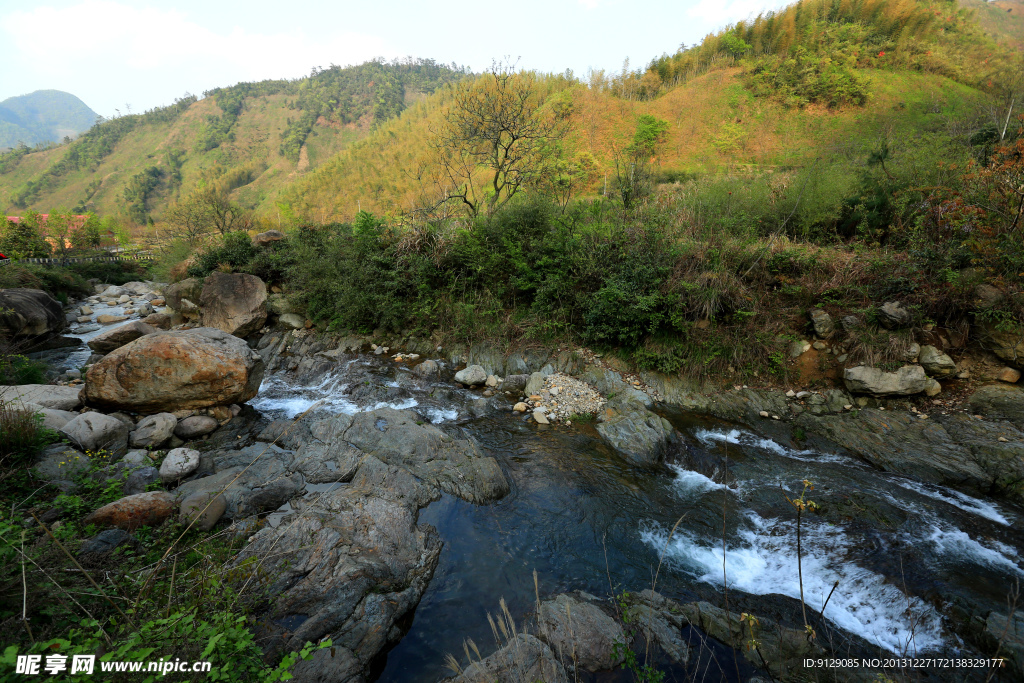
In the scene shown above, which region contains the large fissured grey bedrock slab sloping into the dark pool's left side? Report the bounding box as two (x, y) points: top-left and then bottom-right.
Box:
(234, 457), (441, 682)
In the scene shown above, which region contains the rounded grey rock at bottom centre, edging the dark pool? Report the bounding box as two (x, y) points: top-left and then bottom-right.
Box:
(539, 594), (628, 672)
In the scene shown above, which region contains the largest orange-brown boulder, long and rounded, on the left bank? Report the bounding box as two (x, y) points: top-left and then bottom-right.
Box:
(85, 328), (263, 414)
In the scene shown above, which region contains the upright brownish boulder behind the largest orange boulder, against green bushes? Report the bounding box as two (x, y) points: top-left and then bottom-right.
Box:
(199, 272), (266, 337)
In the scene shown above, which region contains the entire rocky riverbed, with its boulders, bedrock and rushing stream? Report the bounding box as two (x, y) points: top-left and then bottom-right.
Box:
(6, 278), (1024, 681)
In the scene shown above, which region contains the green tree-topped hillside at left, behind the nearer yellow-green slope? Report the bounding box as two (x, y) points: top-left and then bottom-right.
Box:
(0, 59), (465, 223)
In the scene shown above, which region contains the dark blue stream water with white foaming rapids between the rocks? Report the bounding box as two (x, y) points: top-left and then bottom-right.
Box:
(37, 306), (1024, 683)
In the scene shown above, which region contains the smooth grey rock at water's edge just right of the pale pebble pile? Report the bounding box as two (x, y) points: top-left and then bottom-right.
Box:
(597, 400), (674, 467)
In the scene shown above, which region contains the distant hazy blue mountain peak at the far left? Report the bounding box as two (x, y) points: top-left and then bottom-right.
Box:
(0, 90), (99, 150)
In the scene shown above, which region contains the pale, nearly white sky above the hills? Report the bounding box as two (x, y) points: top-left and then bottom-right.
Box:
(0, 0), (788, 117)
